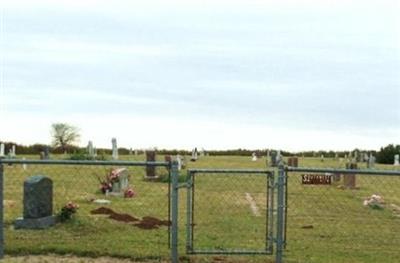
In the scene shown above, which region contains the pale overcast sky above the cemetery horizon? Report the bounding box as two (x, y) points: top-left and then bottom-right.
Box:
(0, 0), (400, 151)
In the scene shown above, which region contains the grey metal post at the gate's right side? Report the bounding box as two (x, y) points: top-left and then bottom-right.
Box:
(275, 164), (286, 263)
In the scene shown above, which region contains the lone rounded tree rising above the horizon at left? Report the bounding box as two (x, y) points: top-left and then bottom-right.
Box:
(51, 123), (80, 152)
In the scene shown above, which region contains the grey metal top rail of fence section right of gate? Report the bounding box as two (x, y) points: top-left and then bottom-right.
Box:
(285, 166), (400, 176)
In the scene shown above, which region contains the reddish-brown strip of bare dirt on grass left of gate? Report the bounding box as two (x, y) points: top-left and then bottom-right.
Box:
(90, 207), (171, 229)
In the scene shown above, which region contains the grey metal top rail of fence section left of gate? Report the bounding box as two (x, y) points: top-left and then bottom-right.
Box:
(0, 158), (171, 167)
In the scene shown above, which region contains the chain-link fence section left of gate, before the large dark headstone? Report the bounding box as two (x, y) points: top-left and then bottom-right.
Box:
(2, 160), (170, 260)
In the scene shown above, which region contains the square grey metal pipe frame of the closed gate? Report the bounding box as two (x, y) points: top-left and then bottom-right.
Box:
(186, 169), (275, 255)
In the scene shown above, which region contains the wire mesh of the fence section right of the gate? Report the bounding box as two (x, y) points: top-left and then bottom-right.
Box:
(285, 169), (400, 263)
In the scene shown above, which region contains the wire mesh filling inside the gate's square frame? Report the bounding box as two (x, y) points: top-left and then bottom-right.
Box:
(188, 170), (272, 254)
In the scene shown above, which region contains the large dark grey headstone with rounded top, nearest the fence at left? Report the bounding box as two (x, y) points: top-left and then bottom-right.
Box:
(14, 175), (55, 229)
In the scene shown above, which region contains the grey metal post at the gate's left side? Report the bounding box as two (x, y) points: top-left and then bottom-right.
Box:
(171, 161), (179, 263)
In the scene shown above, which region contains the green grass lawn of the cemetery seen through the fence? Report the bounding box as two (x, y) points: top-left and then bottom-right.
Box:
(4, 155), (400, 263)
